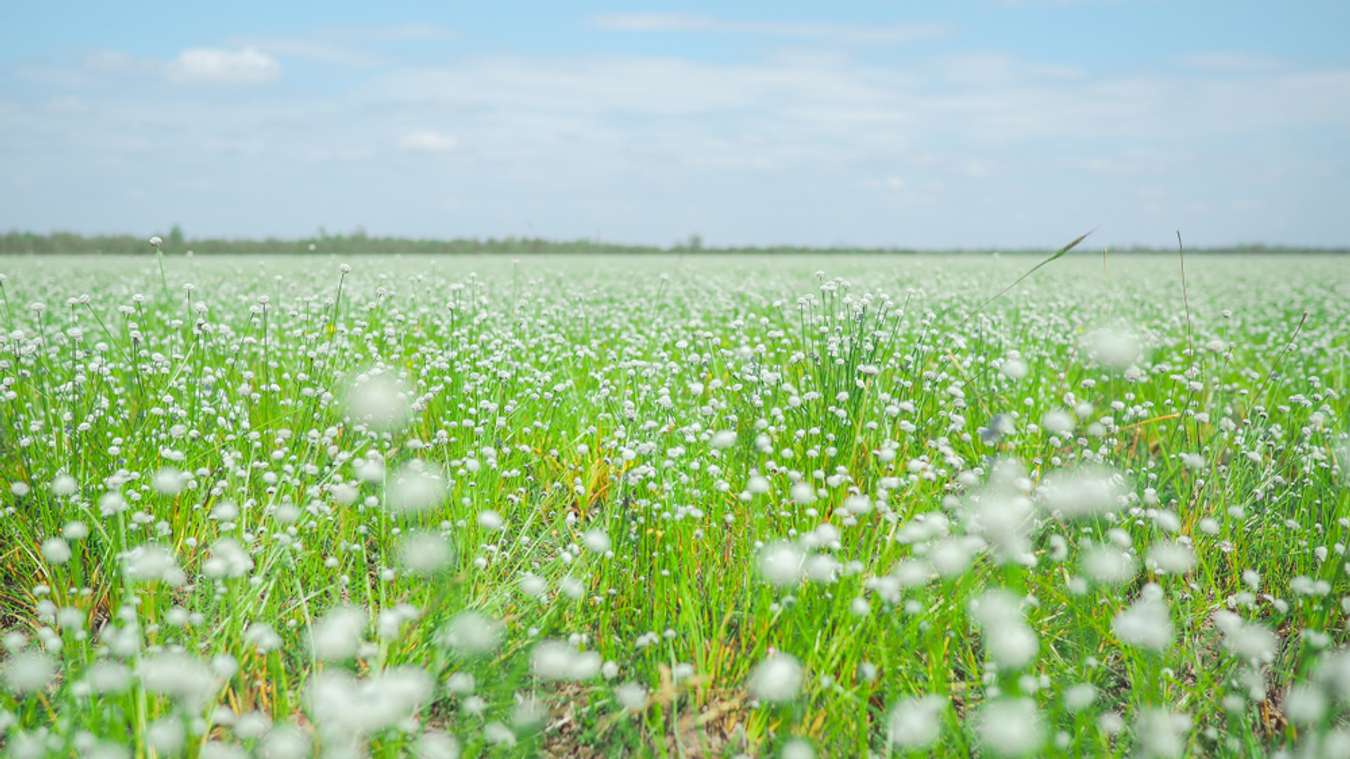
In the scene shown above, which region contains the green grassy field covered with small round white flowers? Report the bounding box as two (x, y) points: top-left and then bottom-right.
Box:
(0, 251), (1350, 759)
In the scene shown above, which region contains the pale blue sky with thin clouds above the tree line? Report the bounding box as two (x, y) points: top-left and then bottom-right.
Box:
(0, 0), (1350, 248)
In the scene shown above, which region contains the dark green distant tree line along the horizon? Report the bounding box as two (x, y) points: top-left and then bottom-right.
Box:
(0, 226), (1350, 255)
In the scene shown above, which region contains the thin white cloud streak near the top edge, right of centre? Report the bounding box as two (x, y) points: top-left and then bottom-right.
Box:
(591, 14), (946, 45)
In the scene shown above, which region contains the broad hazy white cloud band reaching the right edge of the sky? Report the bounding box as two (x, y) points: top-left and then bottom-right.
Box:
(373, 57), (1350, 147)
